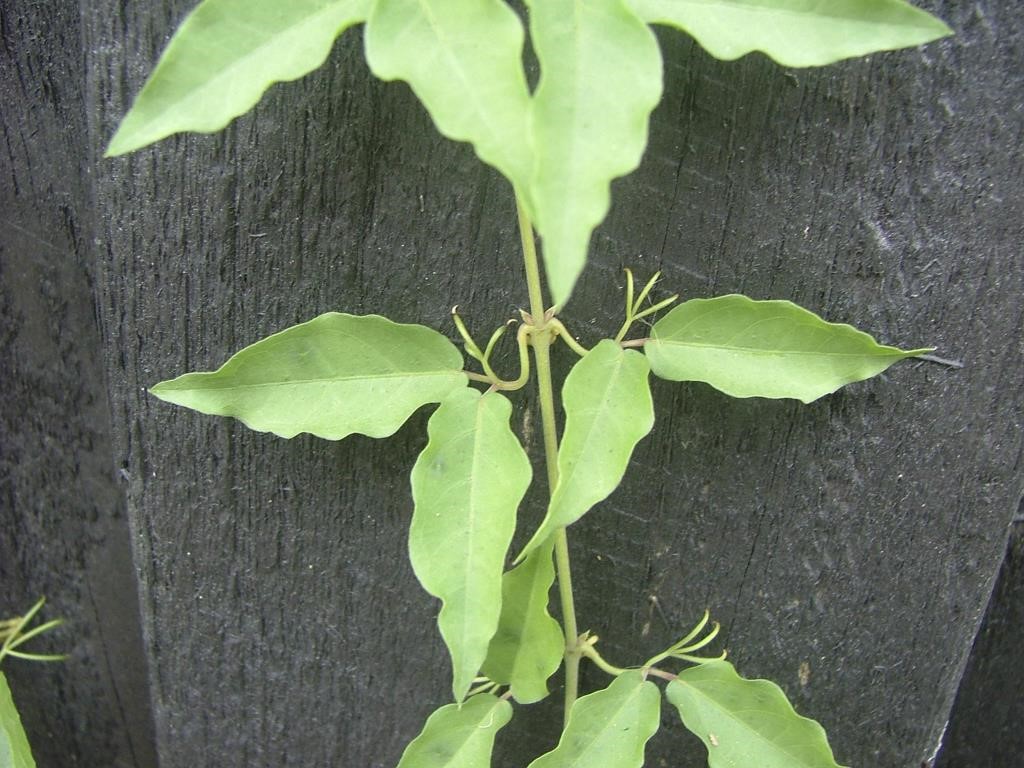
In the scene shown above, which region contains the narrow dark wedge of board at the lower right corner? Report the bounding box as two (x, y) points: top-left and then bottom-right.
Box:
(937, 520), (1024, 768)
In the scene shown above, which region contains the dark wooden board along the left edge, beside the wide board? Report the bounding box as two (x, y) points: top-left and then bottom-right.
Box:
(0, 2), (156, 768)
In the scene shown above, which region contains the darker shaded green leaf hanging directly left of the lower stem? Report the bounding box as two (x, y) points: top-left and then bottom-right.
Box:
(481, 540), (565, 703)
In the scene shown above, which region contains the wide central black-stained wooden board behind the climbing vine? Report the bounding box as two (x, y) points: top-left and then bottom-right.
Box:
(83, 0), (1024, 767)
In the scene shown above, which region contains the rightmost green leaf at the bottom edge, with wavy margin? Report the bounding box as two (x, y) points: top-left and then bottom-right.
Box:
(666, 662), (840, 768)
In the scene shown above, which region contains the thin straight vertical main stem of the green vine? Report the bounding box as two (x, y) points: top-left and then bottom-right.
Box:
(516, 198), (581, 722)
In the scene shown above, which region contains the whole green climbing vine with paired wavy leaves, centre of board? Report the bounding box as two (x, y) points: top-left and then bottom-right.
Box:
(108, 0), (949, 768)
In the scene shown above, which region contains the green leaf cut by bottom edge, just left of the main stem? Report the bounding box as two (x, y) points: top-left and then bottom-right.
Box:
(398, 693), (512, 768)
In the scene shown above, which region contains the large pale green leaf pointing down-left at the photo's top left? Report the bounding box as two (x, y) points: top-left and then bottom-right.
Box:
(106, 0), (370, 157)
